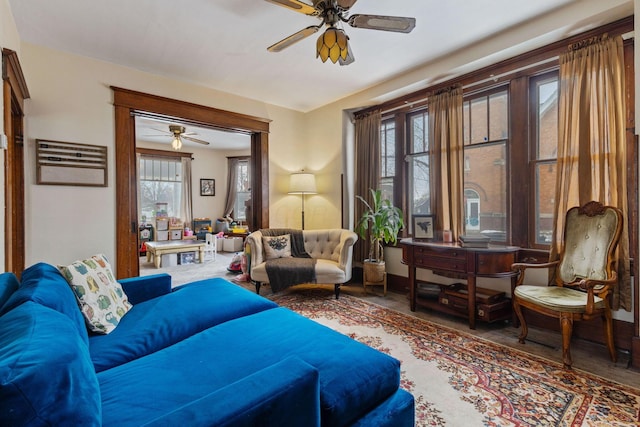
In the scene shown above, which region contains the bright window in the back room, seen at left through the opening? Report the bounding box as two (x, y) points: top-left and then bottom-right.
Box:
(138, 155), (182, 219)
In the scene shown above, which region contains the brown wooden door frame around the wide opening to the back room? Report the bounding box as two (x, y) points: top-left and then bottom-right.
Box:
(111, 87), (270, 278)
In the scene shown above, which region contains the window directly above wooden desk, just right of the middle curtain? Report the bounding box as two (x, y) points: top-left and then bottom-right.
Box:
(463, 88), (509, 242)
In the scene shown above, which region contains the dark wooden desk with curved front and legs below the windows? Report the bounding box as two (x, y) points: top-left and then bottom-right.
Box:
(400, 239), (519, 329)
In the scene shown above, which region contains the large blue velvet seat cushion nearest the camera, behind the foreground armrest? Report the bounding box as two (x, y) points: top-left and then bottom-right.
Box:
(98, 308), (400, 426)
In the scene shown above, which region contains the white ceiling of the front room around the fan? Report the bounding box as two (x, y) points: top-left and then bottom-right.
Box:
(9, 0), (633, 112)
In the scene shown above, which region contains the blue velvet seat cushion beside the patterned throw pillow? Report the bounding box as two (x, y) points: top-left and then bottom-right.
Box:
(89, 278), (277, 372)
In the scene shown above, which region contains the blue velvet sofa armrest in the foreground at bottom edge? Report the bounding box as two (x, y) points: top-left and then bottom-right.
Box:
(145, 356), (320, 427)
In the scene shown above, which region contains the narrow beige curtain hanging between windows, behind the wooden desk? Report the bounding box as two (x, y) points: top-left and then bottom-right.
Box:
(428, 86), (464, 242)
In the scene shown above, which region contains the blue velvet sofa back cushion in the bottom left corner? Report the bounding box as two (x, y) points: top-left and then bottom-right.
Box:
(0, 301), (102, 426)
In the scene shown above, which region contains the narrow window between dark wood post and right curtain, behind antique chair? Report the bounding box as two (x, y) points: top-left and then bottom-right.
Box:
(531, 73), (558, 245)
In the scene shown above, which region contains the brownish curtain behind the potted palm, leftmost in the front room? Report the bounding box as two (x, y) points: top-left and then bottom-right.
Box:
(353, 110), (382, 263)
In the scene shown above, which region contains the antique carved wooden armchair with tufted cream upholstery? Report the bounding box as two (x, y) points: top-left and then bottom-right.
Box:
(512, 201), (623, 369)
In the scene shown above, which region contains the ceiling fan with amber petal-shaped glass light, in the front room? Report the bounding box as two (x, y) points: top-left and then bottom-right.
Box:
(266, 0), (416, 65)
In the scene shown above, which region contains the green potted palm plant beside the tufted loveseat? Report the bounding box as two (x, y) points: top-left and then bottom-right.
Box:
(356, 189), (404, 283)
